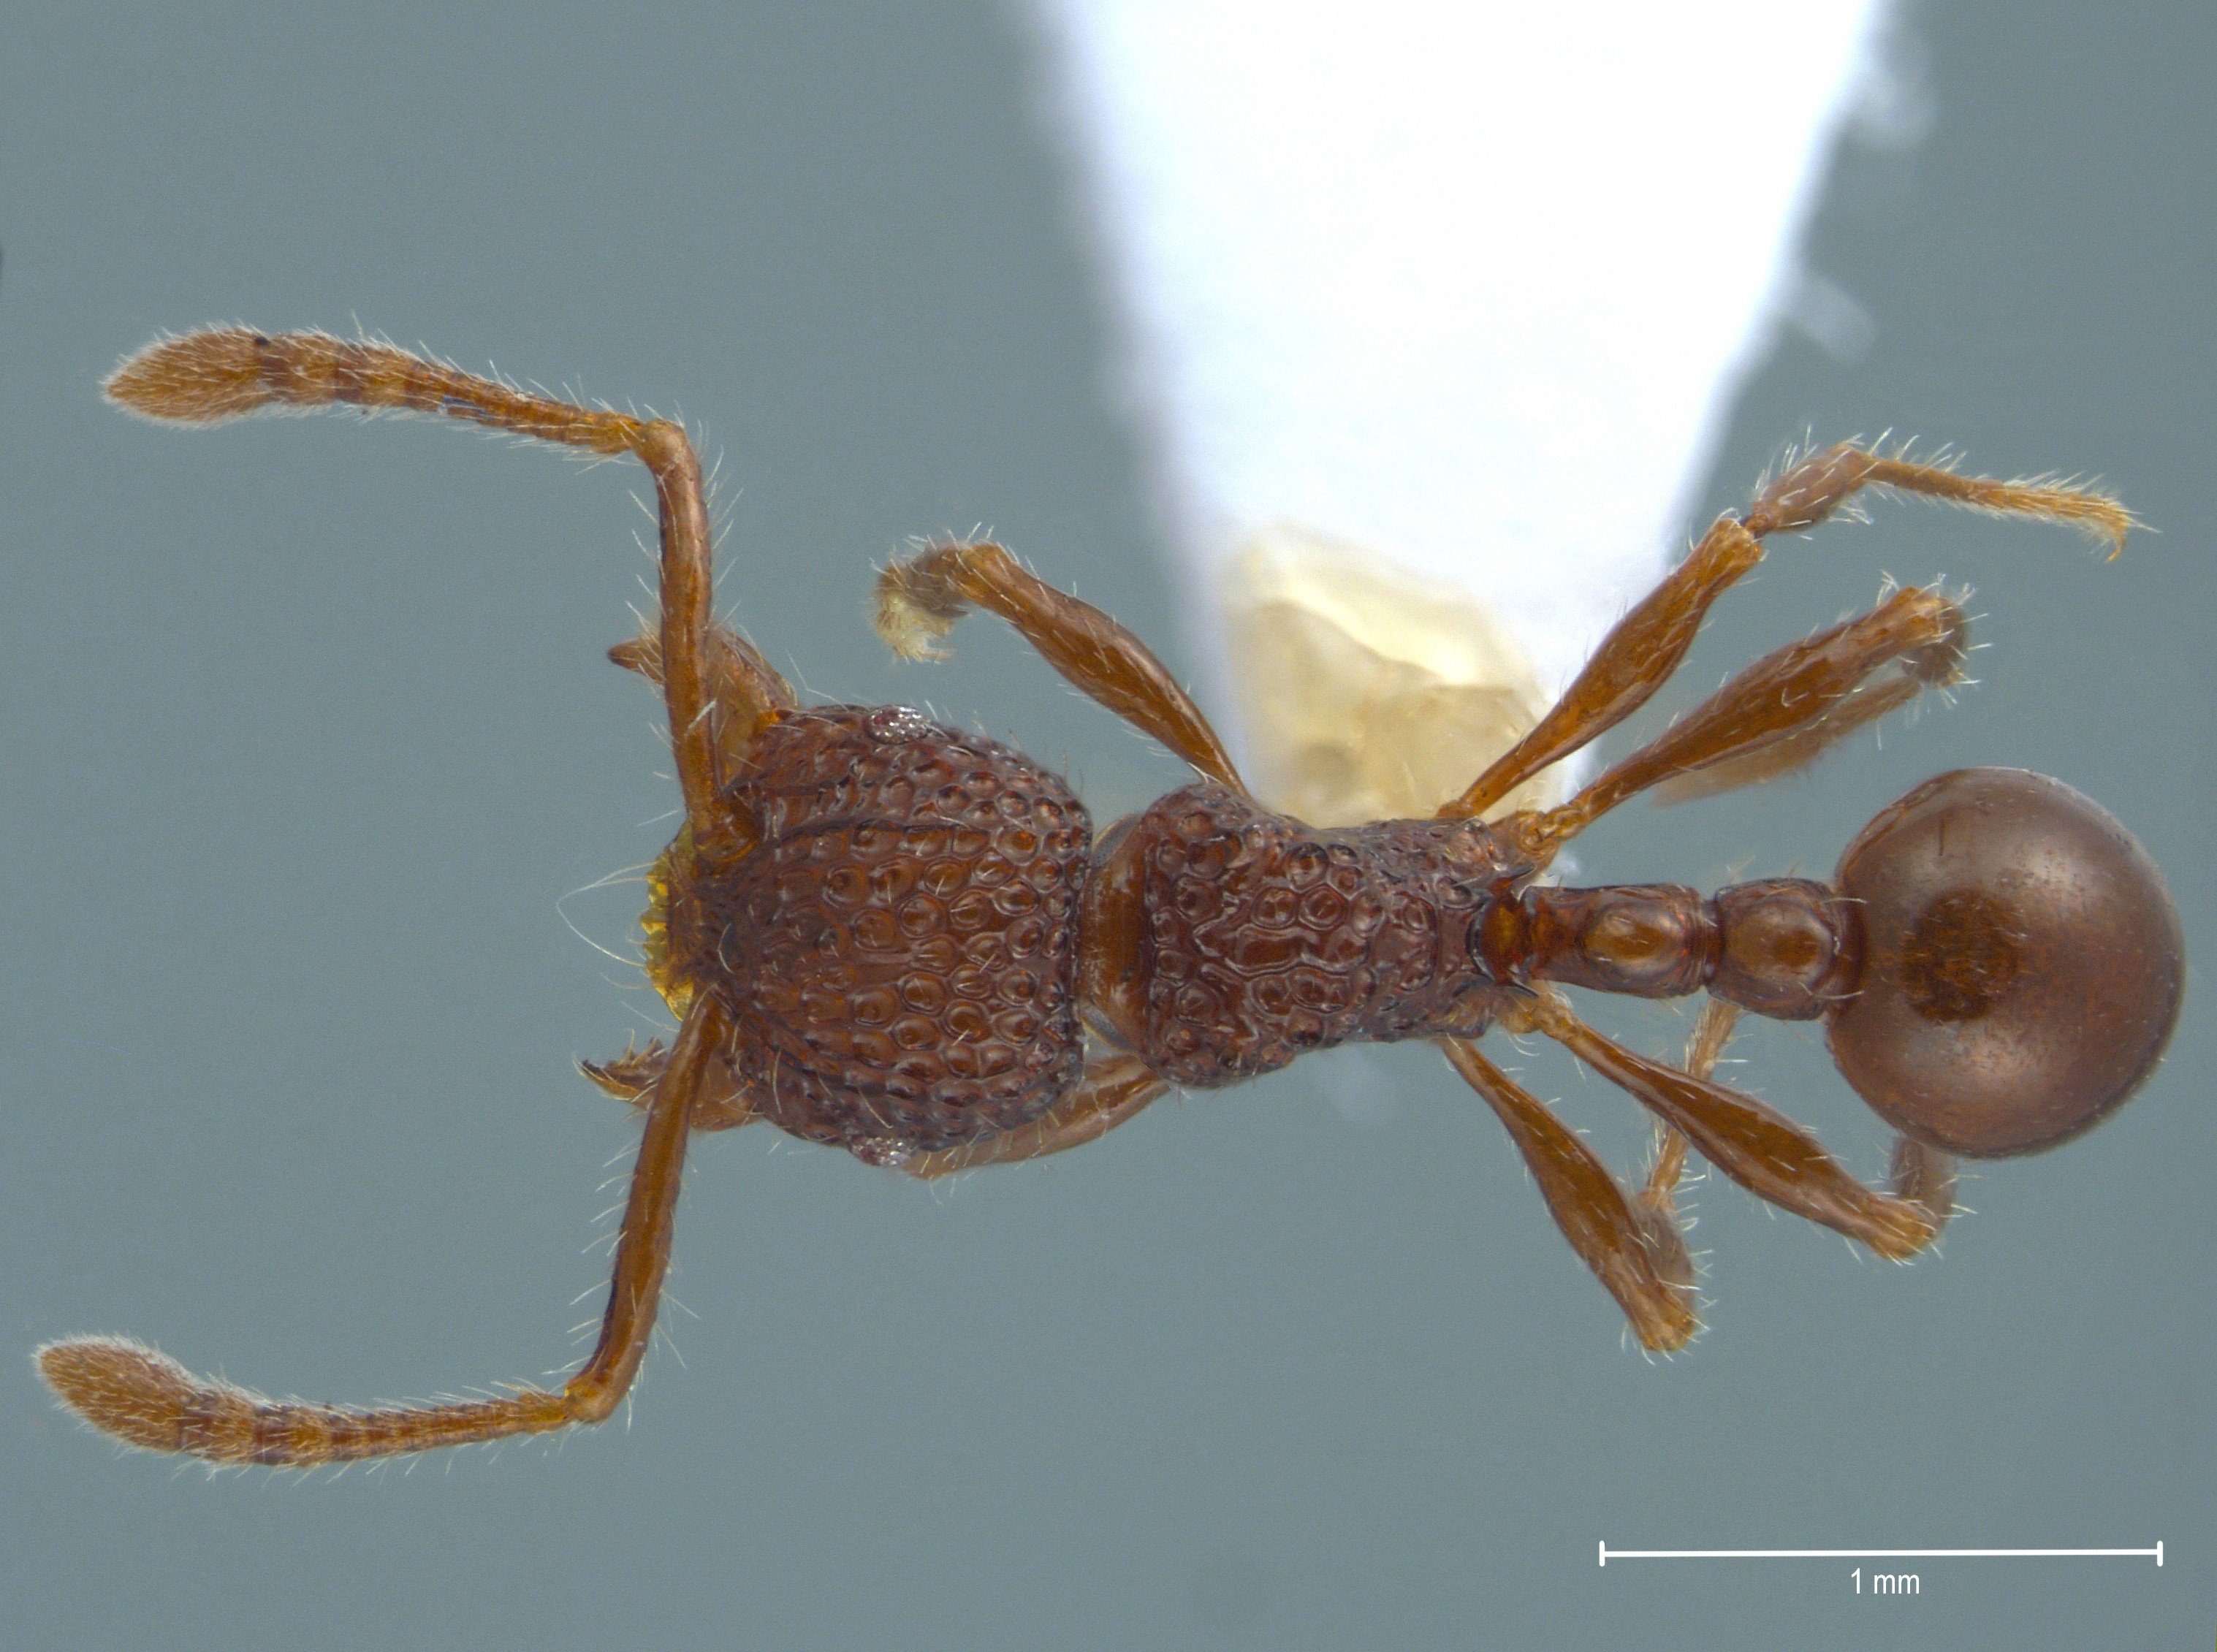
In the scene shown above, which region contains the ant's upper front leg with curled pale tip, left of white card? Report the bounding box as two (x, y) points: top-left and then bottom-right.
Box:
(878, 541), (1246, 796)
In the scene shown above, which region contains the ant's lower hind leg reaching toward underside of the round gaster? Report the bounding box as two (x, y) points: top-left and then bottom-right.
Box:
(1503, 991), (1940, 1262)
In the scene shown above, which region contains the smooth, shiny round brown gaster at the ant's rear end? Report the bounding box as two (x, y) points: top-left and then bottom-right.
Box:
(1829, 769), (2186, 1157)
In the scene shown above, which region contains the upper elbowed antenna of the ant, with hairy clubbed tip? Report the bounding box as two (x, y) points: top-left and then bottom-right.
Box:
(107, 326), (720, 838)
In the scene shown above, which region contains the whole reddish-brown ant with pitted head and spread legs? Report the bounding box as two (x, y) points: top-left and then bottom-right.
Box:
(38, 328), (2183, 1466)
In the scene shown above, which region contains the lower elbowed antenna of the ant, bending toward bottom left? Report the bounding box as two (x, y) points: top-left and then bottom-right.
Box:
(38, 998), (729, 1468)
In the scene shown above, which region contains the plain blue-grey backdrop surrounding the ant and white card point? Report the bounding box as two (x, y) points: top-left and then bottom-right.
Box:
(0, 4), (2217, 1648)
